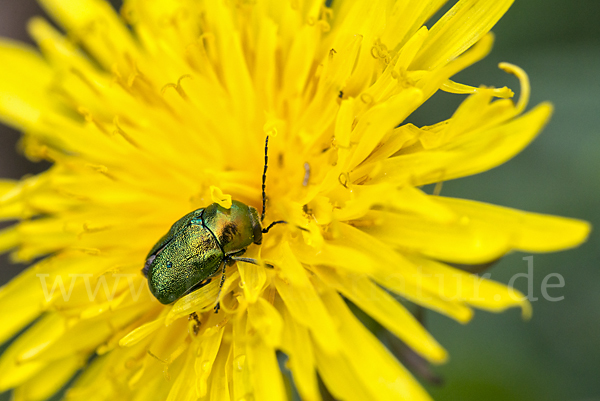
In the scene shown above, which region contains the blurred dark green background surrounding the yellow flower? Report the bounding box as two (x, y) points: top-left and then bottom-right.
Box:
(0, 0), (600, 401)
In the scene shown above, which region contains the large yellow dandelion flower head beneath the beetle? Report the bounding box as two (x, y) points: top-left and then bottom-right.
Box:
(0, 0), (589, 401)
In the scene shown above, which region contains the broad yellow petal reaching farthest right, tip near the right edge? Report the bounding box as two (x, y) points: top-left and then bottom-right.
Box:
(362, 191), (590, 264)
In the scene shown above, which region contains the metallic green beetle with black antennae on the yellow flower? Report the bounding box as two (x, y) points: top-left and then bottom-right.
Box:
(142, 137), (286, 304)
